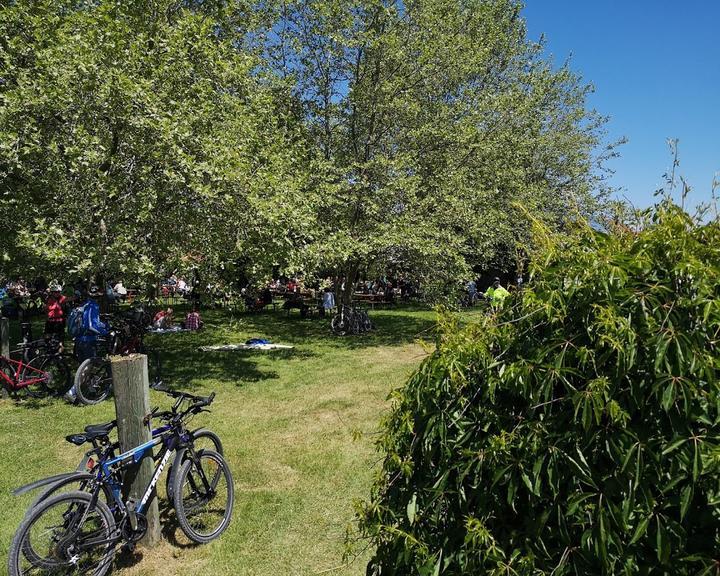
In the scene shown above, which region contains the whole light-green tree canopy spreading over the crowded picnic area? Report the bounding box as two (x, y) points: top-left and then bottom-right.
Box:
(0, 0), (605, 294)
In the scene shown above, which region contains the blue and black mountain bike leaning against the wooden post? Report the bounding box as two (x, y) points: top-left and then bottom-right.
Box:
(8, 393), (234, 576)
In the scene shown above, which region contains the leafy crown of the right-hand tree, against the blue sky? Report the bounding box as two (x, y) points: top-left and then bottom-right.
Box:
(266, 0), (611, 299)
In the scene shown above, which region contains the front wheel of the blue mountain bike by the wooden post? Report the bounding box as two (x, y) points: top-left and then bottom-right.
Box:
(174, 450), (235, 544)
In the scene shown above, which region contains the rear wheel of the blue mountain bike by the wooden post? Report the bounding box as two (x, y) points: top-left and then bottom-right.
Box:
(8, 492), (115, 576)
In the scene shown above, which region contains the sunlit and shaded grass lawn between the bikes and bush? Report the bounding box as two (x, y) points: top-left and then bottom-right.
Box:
(0, 309), (434, 576)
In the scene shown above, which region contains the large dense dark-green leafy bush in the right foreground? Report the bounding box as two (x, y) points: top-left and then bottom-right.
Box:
(358, 203), (720, 576)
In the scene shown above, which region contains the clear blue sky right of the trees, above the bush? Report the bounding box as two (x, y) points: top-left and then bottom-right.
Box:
(524, 0), (720, 207)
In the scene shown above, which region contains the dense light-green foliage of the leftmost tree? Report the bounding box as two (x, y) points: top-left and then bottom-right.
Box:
(0, 1), (314, 286)
